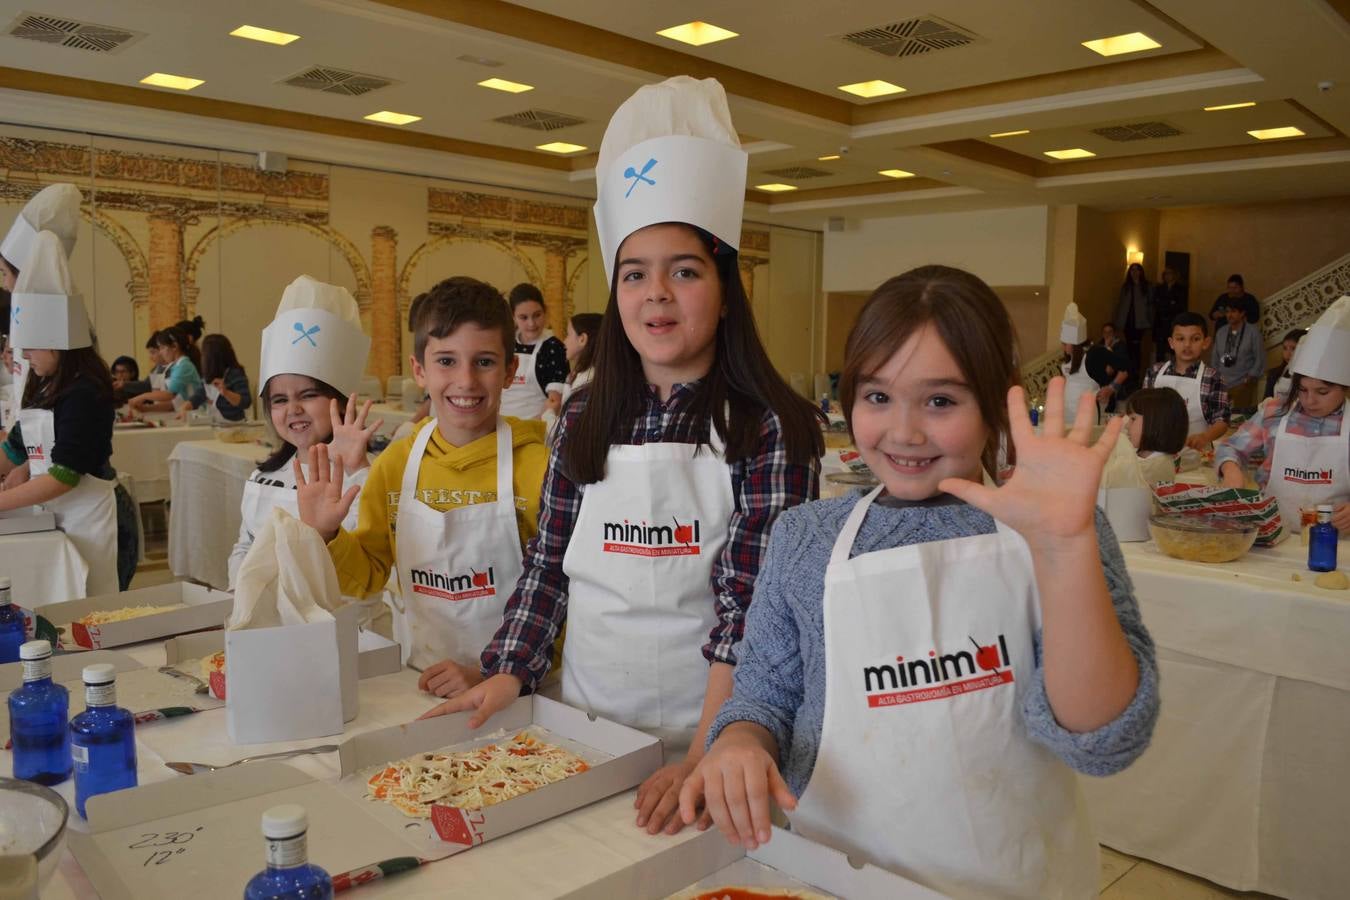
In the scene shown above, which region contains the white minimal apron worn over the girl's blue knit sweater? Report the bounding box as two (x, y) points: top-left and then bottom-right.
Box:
(790, 487), (1099, 900)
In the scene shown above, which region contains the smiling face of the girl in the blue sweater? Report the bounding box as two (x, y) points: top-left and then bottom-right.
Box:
(852, 325), (990, 501)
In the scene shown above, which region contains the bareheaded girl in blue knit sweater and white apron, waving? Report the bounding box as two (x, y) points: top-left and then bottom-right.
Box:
(680, 266), (1158, 899)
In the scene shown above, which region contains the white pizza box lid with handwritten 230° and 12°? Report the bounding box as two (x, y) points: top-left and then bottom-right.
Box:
(69, 762), (406, 900)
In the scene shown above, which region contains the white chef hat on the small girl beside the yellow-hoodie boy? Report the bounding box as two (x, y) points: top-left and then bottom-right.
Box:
(258, 275), (370, 397)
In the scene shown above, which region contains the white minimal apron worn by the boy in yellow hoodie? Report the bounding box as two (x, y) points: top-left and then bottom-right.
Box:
(393, 418), (524, 669)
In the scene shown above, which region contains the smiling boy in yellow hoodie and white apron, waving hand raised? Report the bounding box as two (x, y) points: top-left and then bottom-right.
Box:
(296, 277), (548, 696)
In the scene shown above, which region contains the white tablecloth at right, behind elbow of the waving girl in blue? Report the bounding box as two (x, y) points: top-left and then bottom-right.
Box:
(1083, 538), (1350, 900)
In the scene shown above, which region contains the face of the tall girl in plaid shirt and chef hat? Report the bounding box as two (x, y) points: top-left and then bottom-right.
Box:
(614, 224), (724, 395)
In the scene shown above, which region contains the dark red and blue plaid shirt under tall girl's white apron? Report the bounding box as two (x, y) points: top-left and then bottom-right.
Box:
(482, 382), (821, 688)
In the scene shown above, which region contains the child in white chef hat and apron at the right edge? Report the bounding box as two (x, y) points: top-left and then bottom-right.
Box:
(1214, 296), (1350, 537)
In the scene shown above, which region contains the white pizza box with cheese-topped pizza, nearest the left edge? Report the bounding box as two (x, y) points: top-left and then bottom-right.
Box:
(38, 582), (235, 650)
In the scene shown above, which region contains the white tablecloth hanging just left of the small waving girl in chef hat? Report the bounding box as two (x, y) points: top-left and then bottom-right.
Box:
(169, 440), (269, 590)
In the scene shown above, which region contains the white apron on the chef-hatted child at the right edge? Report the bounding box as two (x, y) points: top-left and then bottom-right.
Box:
(1263, 403), (1350, 534)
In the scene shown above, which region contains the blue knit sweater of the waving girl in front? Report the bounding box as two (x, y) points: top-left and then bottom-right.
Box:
(709, 493), (1158, 796)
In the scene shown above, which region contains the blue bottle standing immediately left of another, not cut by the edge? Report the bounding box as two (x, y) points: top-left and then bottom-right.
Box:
(9, 641), (70, 785)
